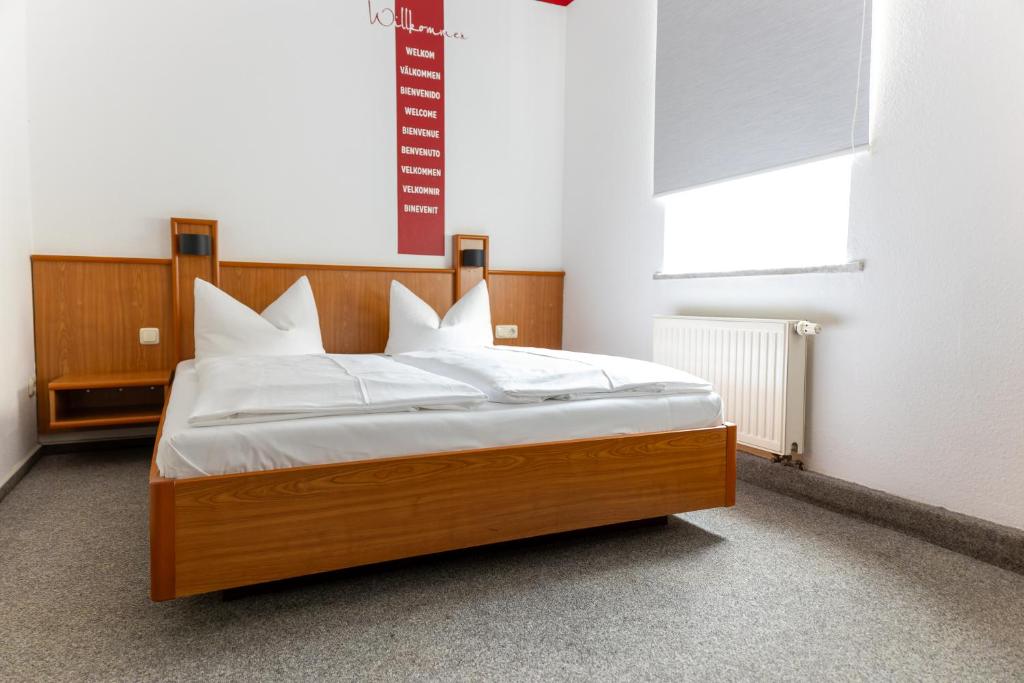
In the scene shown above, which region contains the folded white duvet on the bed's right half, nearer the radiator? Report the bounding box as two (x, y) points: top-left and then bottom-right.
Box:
(392, 346), (712, 403)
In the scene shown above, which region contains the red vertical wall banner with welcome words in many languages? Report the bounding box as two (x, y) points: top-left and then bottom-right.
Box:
(394, 0), (444, 256)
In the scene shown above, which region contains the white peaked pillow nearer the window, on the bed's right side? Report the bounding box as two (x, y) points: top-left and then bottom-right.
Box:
(384, 280), (495, 355)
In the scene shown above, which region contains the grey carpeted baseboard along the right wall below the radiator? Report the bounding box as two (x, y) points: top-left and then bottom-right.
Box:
(736, 453), (1024, 573)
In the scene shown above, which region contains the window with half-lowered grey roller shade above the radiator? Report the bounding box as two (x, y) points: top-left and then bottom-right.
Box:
(653, 0), (871, 274)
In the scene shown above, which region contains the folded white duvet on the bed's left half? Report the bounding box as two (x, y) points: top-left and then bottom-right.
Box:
(188, 354), (486, 427)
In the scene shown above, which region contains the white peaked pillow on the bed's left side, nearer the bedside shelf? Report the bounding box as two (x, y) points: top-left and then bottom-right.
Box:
(195, 275), (324, 359)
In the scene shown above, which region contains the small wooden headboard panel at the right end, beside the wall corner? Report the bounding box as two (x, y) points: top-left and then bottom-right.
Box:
(487, 270), (565, 348)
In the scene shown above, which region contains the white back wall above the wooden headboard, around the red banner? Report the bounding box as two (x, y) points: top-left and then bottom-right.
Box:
(29, 0), (565, 268)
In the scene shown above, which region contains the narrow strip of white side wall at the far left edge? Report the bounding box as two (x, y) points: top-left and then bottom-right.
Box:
(0, 0), (36, 484)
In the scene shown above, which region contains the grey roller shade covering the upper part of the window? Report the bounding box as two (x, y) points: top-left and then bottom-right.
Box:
(654, 0), (871, 194)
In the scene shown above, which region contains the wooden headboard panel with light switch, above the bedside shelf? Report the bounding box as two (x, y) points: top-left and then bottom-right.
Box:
(32, 256), (173, 432)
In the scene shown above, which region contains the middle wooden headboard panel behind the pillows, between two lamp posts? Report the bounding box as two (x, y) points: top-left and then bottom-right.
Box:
(220, 262), (455, 353)
